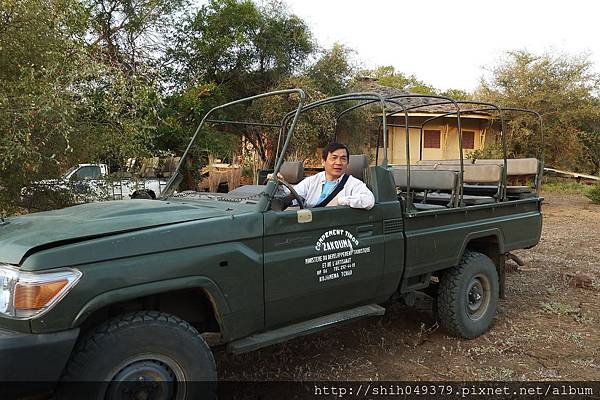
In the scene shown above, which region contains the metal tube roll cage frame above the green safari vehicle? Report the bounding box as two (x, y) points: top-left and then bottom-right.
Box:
(160, 89), (544, 211)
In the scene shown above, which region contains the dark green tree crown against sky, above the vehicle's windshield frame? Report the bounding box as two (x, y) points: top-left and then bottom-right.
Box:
(168, 0), (314, 93)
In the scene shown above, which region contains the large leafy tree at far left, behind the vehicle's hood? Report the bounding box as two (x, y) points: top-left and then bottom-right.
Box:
(0, 0), (166, 211)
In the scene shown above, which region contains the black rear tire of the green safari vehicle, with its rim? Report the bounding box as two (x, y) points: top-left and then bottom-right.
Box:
(435, 251), (500, 339)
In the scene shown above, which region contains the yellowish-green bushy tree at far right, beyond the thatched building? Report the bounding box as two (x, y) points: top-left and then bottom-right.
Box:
(476, 51), (600, 172)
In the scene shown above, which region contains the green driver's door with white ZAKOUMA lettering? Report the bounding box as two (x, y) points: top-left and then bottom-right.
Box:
(264, 205), (384, 328)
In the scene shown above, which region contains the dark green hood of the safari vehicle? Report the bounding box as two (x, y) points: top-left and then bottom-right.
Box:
(0, 199), (239, 265)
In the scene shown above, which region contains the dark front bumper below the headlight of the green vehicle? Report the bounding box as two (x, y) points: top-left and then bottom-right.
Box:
(0, 328), (79, 383)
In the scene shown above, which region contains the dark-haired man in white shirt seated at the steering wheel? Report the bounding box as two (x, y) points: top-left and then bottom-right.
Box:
(274, 143), (375, 210)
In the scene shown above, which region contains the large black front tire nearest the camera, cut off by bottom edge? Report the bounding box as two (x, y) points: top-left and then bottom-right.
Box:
(57, 311), (217, 400)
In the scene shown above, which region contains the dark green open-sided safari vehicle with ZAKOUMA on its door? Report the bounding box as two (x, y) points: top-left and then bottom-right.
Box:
(0, 89), (542, 398)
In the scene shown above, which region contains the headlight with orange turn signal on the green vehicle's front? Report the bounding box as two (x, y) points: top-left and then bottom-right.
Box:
(0, 264), (82, 319)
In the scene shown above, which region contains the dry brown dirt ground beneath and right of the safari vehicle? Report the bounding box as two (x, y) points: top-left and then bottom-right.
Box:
(215, 193), (600, 381)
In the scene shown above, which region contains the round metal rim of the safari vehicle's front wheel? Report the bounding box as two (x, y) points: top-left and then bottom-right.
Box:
(104, 354), (185, 400)
